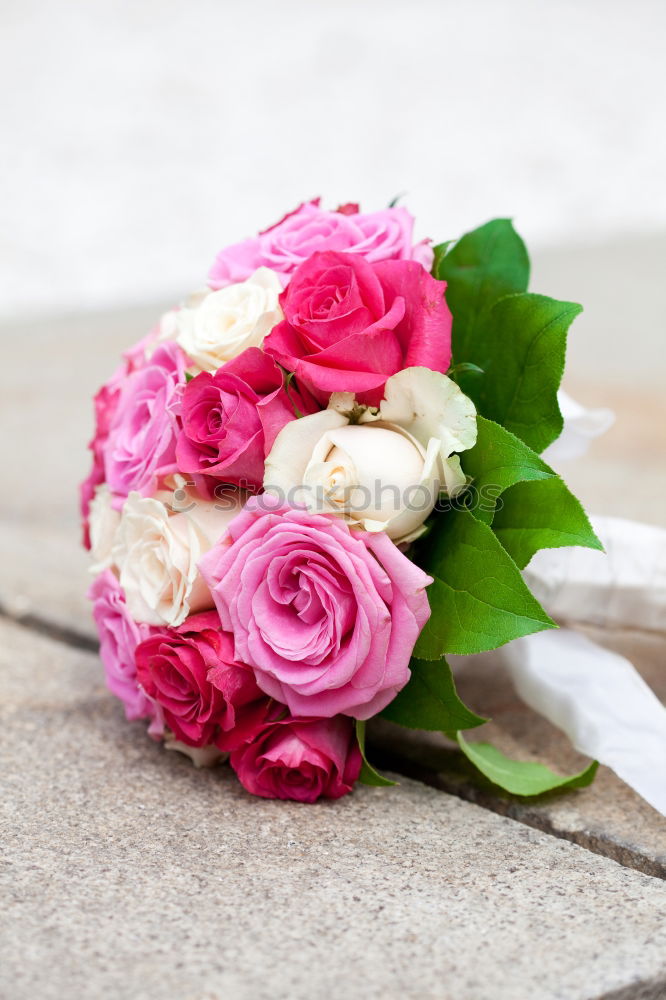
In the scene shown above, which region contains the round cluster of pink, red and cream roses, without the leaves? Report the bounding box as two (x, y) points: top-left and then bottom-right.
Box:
(81, 201), (476, 802)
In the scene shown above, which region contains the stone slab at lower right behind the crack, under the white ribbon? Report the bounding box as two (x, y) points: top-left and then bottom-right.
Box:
(368, 628), (666, 878)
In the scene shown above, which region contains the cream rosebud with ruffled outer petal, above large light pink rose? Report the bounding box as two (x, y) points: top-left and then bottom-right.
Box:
(264, 368), (476, 543)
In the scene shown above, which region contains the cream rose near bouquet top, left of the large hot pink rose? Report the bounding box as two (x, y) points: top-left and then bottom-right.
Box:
(167, 267), (283, 372)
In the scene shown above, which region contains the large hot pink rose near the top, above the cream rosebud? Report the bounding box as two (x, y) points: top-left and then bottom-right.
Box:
(264, 252), (451, 405)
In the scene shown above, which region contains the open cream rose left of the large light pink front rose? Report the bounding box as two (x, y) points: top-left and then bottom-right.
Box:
(112, 491), (245, 626)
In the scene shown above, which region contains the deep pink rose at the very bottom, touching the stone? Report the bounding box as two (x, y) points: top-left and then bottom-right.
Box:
(231, 716), (361, 802)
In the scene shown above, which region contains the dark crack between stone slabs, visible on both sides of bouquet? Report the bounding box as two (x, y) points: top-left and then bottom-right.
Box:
(0, 604), (666, 888)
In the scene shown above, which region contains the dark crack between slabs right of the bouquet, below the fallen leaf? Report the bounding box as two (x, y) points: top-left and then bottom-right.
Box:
(369, 739), (666, 880)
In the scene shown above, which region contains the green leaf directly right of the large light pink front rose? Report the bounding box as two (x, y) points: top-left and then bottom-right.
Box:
(414, 509), (554, 660)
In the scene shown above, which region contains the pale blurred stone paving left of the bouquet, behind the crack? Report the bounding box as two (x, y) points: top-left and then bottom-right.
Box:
(0, 305), (161, 638)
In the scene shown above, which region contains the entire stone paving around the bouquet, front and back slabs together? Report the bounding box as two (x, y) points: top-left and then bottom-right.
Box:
(0, 280), (666, 1000)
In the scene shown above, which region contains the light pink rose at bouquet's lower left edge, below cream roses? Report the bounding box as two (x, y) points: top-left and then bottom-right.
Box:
(88, 569), (155, 719)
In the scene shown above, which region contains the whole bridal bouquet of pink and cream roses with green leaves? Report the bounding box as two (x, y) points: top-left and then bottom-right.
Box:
(81, 201), (600, 802)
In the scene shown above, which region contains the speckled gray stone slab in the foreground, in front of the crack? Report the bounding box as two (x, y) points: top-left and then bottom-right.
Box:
(0, 624), (666, 1000)
